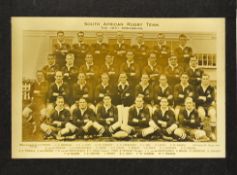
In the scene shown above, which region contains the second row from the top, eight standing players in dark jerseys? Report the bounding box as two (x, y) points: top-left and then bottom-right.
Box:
(42, 50), (203, 91)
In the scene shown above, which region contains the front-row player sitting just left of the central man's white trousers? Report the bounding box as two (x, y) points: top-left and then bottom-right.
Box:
(97, 95), (121, 136)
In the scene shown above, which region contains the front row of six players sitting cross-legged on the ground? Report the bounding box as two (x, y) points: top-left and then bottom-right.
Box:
(40, 96), (214, 141)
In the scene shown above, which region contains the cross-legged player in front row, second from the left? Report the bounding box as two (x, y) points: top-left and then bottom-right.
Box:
(70, 98), (105, 139)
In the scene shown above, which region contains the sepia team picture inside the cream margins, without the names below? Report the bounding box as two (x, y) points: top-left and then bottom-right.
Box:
(11, 17), (224, 157)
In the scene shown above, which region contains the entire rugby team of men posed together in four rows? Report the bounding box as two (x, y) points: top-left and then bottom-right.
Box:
(23, 32), (216, 141)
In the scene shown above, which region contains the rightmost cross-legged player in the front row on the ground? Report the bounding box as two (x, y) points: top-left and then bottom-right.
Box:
(175, 97), (209, 141)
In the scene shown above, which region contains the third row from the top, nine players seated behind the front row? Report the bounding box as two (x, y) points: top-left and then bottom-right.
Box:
(28, 71), (215, 110)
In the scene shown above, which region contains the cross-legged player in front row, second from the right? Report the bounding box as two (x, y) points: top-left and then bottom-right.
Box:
(143, 97), (178, 141)
